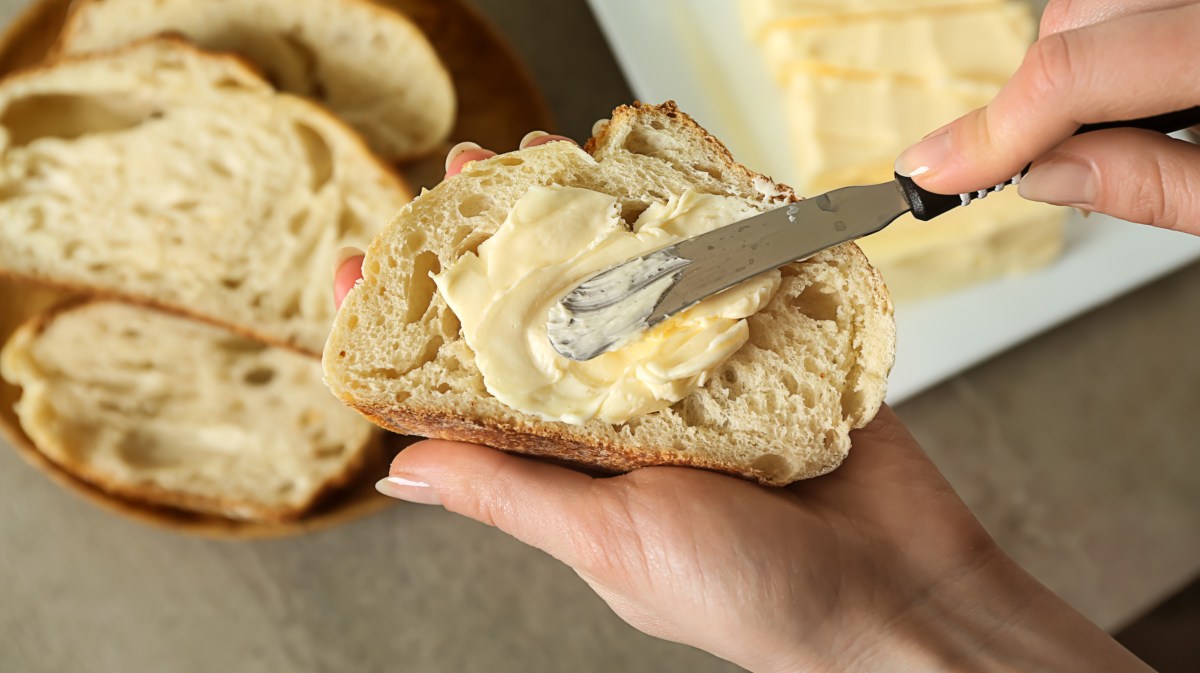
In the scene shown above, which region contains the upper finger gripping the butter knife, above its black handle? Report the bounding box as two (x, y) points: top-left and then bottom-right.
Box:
(896, 5), (1200, 194)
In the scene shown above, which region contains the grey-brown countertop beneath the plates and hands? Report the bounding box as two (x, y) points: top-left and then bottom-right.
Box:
(0, 0), (1200, 673)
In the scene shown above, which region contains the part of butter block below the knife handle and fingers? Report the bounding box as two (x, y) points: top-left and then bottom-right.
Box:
(858, 191), (1069, 301)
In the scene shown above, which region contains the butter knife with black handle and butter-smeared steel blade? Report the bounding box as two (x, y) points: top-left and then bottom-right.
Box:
(546, 107), (1200, 360)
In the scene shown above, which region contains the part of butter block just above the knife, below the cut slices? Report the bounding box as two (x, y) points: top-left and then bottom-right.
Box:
(785, 72), (1000, 194)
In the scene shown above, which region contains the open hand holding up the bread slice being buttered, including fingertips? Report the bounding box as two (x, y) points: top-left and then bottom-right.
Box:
(335, 134), (1145, 672)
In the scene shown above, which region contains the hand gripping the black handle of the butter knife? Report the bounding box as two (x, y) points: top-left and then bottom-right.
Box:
(896, 0), (1200, 234)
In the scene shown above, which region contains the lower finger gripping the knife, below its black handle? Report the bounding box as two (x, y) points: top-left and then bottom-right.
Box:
(1020, 128), (1200, 234)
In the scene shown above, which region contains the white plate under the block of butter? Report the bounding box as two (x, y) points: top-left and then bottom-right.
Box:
(589, 0), (1200, 403)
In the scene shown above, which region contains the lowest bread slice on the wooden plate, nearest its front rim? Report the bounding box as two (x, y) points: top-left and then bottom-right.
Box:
(0, 301), (378, 521)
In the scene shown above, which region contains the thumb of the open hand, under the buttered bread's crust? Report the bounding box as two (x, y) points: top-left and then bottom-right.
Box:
(378, 440), (601, 565)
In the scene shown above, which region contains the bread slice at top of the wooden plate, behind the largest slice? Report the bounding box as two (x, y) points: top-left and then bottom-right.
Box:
(51, 0), (455, 161)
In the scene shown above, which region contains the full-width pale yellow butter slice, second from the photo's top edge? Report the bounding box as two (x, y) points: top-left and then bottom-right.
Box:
(762, 2), (1034, 84)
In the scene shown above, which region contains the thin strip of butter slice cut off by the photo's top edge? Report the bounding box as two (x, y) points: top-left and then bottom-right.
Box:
(742, 0), (1004, 40)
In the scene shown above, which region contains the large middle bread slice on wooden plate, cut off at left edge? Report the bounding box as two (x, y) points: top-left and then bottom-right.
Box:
(0, 40), (409, 354)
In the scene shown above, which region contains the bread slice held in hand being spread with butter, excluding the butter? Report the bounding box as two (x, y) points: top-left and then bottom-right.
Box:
(324, 103), (895, 483)
